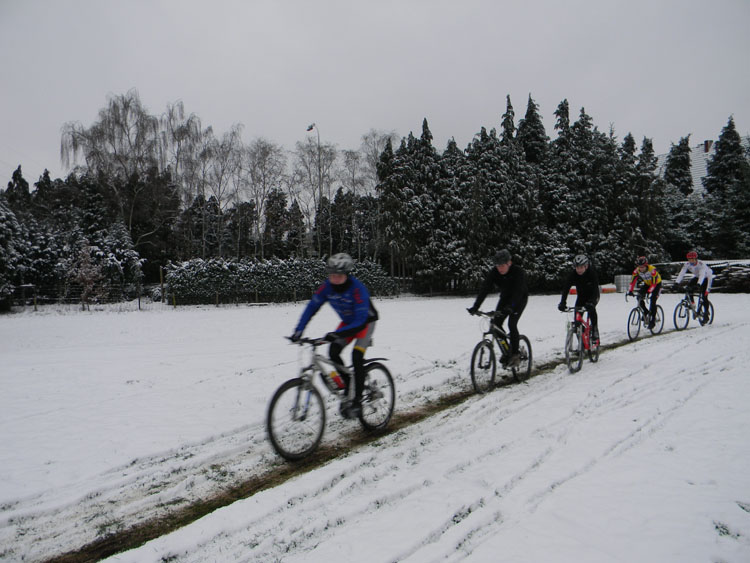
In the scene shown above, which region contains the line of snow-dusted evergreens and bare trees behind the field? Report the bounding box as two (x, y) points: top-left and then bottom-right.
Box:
(0, 91), (750, 308)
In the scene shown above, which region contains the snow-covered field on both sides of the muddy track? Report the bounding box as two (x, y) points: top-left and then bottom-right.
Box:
(0, 294), (750, 563)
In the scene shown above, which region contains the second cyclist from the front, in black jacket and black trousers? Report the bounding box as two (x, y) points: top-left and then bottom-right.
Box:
(467, 249), (529, 367)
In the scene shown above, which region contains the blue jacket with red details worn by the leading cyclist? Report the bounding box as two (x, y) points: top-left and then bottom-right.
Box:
(296, 276), (378, 337)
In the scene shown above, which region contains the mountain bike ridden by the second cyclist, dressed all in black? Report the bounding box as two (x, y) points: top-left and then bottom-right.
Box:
(471, 311), (532, 393)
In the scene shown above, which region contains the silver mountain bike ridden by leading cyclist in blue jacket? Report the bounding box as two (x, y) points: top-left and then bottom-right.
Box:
(266, 338), (396, 461)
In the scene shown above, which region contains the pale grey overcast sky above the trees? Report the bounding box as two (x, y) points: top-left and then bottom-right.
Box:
(0, 0), (750, 187)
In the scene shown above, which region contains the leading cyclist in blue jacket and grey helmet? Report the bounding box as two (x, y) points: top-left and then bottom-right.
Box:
(291, 253), (378, 418)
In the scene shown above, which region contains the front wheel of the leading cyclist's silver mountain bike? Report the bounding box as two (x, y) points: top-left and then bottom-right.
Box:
(266, 378), (326, 461)
